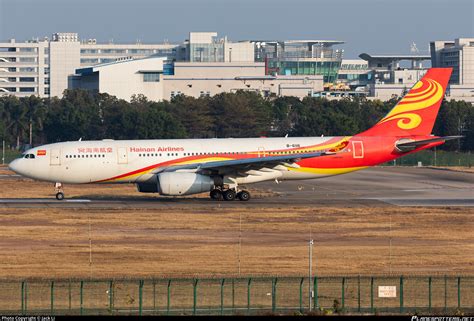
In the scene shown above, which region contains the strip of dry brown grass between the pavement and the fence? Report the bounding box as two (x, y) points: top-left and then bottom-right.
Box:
(0, 207), (474, 277)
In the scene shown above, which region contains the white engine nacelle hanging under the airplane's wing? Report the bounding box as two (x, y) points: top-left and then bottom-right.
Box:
(158, 172), (214, 196)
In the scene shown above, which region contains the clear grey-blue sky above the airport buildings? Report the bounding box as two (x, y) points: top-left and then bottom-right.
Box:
(0, 0), (474, 59)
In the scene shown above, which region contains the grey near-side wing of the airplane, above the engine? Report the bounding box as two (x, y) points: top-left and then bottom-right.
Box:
(154, 152), (335, 174)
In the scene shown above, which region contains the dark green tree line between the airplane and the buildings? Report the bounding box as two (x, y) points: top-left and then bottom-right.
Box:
(0, 89), (474, 151)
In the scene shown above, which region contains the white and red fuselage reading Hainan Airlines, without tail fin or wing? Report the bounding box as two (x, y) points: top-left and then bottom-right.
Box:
(10, 136), (438, 184)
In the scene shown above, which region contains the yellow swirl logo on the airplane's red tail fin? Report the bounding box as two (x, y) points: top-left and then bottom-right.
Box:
(379, 78), (443, 130)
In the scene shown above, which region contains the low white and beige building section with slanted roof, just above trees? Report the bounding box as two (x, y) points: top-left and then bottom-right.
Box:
(70, 57), (323, 101)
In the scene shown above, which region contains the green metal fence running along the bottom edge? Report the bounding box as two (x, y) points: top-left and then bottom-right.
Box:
(0, 276), (474, 315)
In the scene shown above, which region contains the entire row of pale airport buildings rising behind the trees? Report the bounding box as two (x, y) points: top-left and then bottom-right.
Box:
(0, 32), (474, 102)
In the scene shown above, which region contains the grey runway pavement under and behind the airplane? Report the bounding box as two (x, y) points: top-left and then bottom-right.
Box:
(0, 167), (474, 208)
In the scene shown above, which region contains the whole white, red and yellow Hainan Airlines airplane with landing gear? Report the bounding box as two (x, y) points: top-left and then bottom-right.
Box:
(9, 68), (458, 201)
